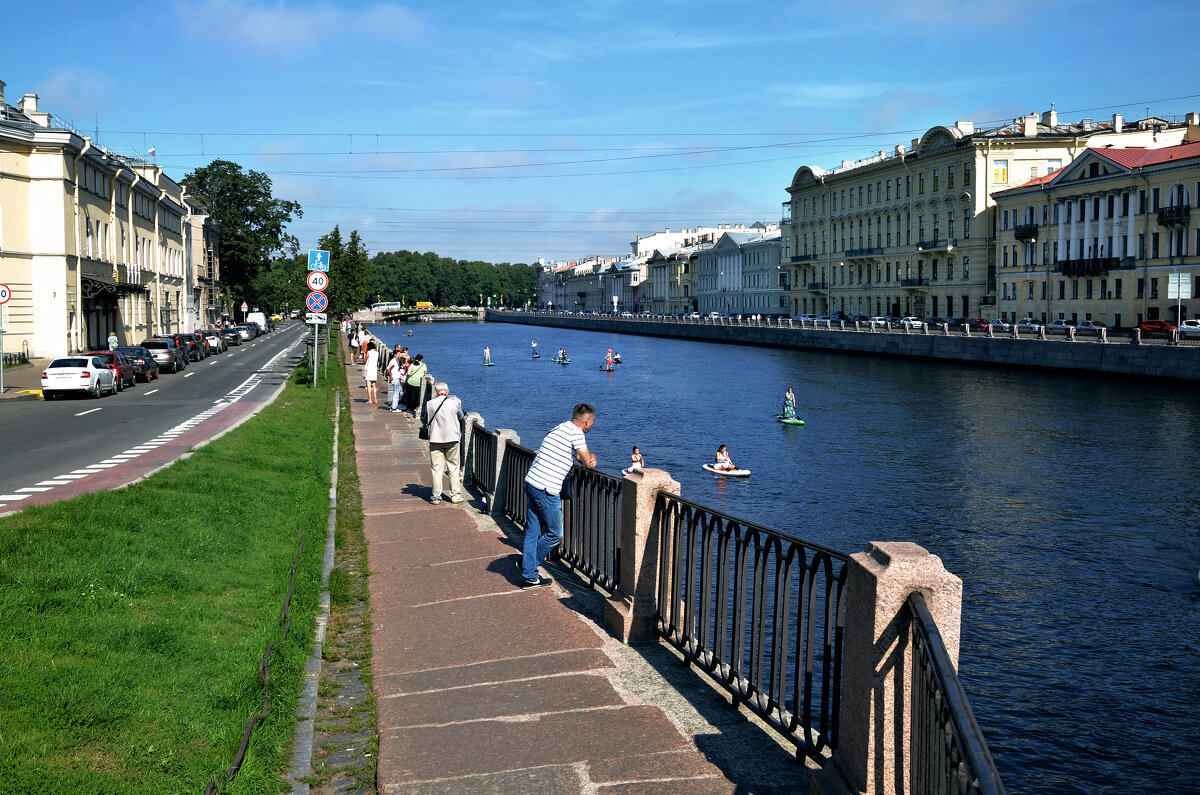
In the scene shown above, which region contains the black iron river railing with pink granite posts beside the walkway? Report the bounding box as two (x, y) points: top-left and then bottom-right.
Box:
(463, 413), (1003, 794)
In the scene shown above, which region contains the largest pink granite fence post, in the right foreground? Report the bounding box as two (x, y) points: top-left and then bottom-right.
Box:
(810, 542), (962, 795)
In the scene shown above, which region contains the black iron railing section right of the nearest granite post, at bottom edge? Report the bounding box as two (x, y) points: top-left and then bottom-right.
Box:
(901, 592), (1004, 795)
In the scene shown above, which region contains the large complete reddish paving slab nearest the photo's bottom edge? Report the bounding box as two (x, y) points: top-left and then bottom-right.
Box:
(377, 706), (688, 790)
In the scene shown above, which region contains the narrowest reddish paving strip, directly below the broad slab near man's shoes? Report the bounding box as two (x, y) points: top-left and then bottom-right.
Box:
(374, 648), (613, 698)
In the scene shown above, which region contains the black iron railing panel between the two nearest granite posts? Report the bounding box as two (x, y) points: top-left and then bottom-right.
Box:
(652, 492), (848, 760)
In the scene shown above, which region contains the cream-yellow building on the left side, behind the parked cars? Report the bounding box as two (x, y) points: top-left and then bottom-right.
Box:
(0, 82), (199, 357)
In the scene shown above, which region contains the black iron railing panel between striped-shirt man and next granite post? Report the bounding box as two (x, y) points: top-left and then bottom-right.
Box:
(559, 466), (620, 591)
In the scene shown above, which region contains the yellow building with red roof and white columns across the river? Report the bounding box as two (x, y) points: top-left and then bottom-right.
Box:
(994, 133), (1200, 328)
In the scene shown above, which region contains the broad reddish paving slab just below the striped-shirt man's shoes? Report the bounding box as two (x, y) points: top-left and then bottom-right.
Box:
(371, 586), (601, 676)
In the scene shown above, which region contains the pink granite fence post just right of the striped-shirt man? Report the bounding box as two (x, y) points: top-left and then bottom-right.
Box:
(604, 470), (679, 644)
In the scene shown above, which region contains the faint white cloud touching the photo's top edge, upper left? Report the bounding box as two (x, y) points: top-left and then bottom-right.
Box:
(175, 0), (424, 58)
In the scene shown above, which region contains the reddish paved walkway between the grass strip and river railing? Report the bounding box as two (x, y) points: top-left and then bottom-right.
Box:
(350, 389), (734, 795)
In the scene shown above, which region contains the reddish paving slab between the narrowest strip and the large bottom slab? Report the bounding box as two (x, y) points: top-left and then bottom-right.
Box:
(377, 677), (623, 731)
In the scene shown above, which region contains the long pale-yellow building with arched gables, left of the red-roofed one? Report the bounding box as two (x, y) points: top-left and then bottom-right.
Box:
(781, 110), (1183, 317)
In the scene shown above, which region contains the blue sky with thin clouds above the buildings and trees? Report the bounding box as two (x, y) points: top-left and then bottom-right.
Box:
(7, 0), (1200, 262)
